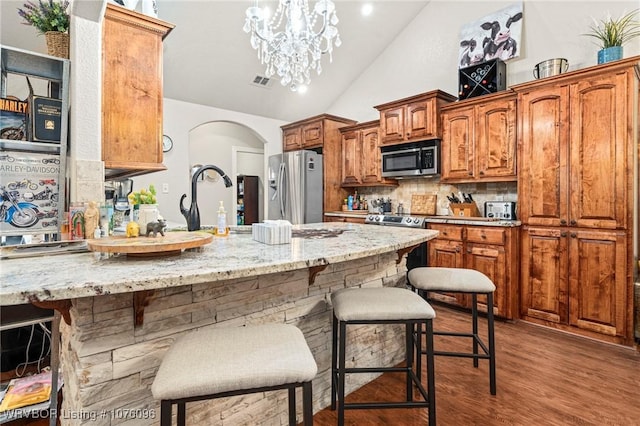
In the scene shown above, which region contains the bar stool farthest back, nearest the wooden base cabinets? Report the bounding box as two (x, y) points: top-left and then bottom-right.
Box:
(407, 266), (496, 395)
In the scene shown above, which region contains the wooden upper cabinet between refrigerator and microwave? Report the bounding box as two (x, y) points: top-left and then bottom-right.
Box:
(340, 120), (398, 187)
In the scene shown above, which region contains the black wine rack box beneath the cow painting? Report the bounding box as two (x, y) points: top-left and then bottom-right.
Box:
(458, 59), (507, 100)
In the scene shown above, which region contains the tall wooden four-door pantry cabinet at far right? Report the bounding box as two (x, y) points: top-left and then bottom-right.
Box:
(513, 57), (640, 344)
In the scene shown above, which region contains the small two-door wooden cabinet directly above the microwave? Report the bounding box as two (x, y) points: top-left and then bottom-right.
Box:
(375, 90), (456, 145)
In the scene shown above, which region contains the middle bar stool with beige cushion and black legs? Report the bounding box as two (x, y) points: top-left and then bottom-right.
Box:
(331, 287), (436, 426)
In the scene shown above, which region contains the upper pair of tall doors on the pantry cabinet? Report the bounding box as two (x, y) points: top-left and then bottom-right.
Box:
(516, 61), (638, 229)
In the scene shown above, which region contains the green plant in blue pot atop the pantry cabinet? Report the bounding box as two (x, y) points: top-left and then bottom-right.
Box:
(584, 9), (640, 64)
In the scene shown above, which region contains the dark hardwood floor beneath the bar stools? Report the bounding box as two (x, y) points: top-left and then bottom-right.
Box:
(314, 305), (640, 426)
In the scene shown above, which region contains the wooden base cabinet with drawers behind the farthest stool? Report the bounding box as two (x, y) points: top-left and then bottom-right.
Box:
(428, 223), (520, 319)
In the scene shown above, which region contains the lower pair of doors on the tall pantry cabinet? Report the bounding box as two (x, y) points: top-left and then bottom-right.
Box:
(521, 227), (631, 342)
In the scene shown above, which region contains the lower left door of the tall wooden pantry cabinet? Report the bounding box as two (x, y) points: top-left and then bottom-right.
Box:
(520, 228), (569, 324)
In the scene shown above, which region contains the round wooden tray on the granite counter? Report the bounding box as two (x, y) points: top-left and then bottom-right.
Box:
(87, 231), (213, 256)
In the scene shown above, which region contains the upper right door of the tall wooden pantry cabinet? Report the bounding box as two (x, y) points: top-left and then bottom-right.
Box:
(569, 73), (633, 229)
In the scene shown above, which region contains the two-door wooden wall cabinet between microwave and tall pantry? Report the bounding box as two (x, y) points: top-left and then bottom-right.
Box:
(441, 91), (517, 183)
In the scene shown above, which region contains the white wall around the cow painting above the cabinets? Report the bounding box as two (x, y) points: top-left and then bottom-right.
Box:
(327, 0), (640, 121)
